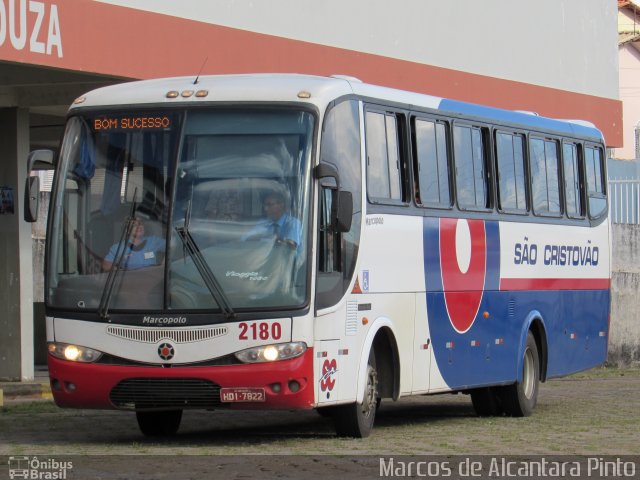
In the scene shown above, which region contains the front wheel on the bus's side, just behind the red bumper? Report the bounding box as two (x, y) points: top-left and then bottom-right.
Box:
(333, 352), (380, 438)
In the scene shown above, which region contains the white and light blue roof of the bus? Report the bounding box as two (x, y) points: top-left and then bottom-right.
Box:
(70, 74), (603, 142)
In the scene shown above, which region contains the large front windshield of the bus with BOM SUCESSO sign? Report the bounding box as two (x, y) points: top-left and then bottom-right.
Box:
(47, 107), (315, 318)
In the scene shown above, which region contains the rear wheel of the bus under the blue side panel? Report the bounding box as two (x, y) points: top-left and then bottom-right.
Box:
(501, 332), (540, 417)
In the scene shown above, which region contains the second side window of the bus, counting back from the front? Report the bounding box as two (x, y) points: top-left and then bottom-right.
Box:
(412, 118), (451, 207)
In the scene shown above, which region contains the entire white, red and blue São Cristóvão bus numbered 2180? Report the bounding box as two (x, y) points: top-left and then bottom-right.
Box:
(25, 74), (611, 437)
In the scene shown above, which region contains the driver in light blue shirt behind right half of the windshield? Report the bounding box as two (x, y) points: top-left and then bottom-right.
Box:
(242, 192), (302, 250)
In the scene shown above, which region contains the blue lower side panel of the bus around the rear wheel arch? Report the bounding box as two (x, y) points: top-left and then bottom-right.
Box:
(426, 290), (609, 390)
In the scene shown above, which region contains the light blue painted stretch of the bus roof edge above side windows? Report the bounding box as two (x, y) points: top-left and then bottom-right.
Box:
(439, 99), (602, 142)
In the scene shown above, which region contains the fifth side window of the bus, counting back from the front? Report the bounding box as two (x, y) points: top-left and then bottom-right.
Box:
(529, 138), (561, 216)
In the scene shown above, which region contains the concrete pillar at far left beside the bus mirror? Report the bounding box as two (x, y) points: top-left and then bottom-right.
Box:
(0, 108), (33, 381)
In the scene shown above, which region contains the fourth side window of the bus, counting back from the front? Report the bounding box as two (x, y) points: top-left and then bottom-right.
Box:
(496, 132), (527, 212)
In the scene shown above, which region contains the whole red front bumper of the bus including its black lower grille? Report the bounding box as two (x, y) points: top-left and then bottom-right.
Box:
(48, 349), (315, 410)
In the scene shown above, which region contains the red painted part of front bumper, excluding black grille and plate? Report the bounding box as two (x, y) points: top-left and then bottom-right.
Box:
(49, 349), (314, 409)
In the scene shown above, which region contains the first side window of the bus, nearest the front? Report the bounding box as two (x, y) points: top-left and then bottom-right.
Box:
(366, 112), (403, 202)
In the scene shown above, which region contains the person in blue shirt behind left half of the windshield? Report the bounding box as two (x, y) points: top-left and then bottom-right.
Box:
(102, 218), (165, 270)
